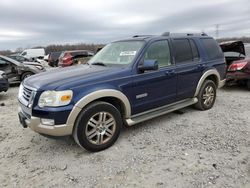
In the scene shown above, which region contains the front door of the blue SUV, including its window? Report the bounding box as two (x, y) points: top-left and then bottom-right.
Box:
(132, 40), (177, 114)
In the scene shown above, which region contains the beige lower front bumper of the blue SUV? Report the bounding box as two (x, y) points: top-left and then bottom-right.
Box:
(18, 107), (73, 136)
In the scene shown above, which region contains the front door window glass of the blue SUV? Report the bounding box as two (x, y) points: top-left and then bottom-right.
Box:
(144, 40), (172, 68)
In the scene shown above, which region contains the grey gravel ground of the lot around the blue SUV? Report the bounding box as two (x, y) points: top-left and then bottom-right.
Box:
(0, 87), (250, 188)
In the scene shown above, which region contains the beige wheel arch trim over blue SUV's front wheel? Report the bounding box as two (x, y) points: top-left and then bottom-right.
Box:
(67, 89), (131, 130)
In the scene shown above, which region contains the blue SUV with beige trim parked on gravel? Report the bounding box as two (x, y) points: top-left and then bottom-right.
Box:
(18, 33), (226, 151)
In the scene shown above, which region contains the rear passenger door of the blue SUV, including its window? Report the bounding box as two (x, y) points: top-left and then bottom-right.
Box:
(172, 38), (203, 100)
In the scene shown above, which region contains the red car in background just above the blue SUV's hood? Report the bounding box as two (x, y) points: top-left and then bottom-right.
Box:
(58, 50), (94, 67)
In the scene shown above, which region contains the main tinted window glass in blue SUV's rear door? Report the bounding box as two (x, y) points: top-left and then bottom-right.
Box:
(173, 39), (193, 63)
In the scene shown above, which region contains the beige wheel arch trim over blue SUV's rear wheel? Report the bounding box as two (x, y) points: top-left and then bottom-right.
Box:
(194, 69), (220, 97)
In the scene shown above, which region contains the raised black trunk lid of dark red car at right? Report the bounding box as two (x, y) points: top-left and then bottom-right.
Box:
(220, 41), (246, 55)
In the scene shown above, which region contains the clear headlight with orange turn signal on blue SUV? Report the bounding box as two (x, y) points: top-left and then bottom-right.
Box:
(38, 90), (73, 108)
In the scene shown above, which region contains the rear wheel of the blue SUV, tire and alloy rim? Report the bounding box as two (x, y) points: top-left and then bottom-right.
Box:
(195, 80), (216, 111)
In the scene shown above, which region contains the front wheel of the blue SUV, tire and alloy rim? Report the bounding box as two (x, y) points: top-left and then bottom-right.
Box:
(73, 101), (122, 152)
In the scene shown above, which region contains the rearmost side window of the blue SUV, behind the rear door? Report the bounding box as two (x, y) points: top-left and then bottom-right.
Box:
(201, 38), (223, 60)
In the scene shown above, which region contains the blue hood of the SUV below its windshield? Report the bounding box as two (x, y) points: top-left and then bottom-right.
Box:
(24, 65), (127, 91)
